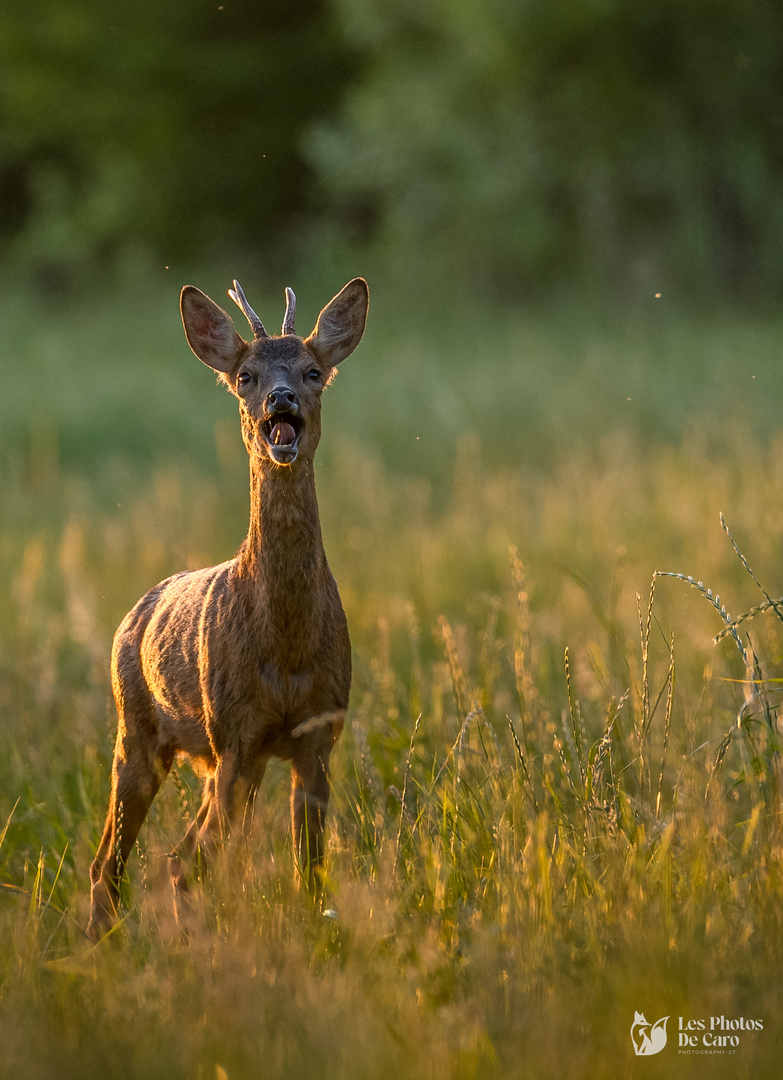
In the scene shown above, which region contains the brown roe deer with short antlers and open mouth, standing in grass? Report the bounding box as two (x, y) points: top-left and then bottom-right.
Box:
(87, 278), (368, 940)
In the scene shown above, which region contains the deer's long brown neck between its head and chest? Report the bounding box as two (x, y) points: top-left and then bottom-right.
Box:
(238, 458), (326, 634)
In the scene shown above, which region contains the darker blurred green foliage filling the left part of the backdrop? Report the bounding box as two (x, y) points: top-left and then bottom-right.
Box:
(0, 0), (349, 284)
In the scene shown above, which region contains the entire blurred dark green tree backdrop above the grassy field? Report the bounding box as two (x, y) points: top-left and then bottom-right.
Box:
(0, 0), (783, 298)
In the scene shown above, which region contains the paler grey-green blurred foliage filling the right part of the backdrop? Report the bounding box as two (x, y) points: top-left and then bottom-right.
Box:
(313, 0), (783, 294)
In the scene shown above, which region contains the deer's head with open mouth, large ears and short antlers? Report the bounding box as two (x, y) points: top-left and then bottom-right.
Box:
(179, 278), (369, 465)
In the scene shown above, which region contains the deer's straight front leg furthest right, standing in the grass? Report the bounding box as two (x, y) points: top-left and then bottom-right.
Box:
(291, 743), (332, 900)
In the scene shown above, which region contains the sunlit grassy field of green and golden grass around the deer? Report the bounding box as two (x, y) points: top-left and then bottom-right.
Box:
(0, 281), (783, 1080)
